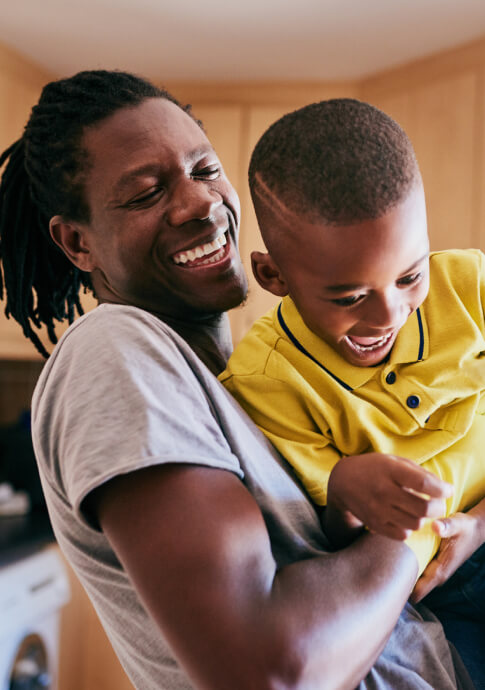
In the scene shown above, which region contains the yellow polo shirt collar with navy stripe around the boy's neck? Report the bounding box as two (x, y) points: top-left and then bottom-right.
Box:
(275, 296), (429, 390)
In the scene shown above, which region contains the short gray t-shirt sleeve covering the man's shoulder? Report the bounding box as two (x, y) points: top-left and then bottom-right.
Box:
(33, 309), (242, 513)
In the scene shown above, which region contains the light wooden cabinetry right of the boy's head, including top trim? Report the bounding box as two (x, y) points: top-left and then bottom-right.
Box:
(360, 34), (485, 249)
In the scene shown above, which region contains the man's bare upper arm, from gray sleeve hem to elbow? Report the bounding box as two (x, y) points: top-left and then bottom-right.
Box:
(95, 465), (275, 688)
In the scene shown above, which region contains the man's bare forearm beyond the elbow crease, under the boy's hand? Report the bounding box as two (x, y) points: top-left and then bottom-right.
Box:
(266, 534), (417, 688)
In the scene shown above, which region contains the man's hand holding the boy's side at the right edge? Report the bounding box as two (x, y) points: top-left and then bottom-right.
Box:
(411, 500), (485, 603)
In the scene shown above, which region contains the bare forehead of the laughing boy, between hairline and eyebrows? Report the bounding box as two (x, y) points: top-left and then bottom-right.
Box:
(253, 179), (429, 285)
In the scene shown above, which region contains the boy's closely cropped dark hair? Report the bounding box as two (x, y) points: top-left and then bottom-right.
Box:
(249, 98), (420, 225)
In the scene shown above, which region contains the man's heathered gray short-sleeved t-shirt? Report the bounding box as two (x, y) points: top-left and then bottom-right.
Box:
(32, 304), (467, 690)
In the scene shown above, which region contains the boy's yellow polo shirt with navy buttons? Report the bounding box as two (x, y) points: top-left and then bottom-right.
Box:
(220, 250), (485, 572)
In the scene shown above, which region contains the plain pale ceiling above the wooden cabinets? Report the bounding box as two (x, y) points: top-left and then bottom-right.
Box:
(0, 0), (485, 82)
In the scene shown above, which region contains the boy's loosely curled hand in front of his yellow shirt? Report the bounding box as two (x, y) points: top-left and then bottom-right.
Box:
(328, 453), (453, 540)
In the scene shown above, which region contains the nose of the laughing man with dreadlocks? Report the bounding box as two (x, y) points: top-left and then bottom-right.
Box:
(167, 180), (222, 227)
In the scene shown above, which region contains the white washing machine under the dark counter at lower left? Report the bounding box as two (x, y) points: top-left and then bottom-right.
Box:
(0, 548), (69, 690)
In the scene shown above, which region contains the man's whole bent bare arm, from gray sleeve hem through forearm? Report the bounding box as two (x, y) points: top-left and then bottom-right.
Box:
(94, 466), (416, 690)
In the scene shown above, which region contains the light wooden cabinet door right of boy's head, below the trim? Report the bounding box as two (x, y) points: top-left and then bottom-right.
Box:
(365, 70), (476, 249)
